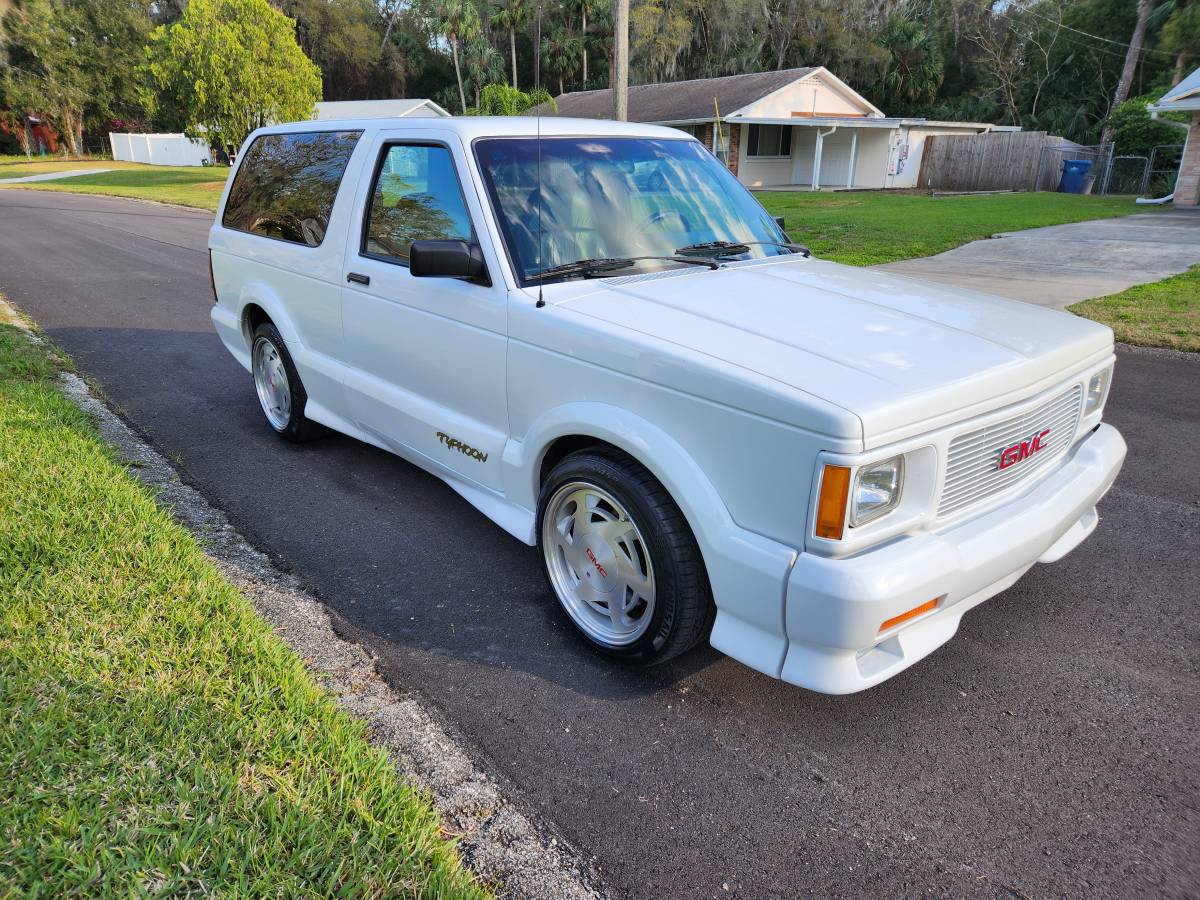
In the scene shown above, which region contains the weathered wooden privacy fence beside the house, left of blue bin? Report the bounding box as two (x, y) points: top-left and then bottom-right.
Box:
(917, 131), (1082, 191)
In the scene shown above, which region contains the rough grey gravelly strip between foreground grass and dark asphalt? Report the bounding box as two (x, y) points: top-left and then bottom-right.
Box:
(0, 296), (606, 900)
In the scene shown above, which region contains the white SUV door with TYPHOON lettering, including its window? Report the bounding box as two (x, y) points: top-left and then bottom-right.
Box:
(342, 134), (508, 490)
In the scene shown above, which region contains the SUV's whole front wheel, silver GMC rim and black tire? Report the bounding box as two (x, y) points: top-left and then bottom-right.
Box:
(538, 450), (715, 664)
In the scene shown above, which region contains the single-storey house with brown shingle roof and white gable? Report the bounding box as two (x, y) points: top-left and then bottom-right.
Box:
(541, 66), (997, 190)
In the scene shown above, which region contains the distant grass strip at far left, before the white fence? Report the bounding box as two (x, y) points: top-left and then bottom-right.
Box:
(0, 160), (229, 210)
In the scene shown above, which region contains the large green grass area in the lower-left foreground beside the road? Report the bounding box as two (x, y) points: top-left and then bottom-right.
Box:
(0, 325), (482, 896)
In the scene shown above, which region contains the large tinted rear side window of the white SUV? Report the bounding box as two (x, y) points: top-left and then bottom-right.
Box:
(221, 131), (362, 247)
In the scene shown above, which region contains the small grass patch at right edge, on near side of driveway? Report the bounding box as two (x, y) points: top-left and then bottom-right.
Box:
(1067, 265), (1200, 353)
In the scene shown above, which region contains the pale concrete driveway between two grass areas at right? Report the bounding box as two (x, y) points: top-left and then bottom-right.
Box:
(877, 210), (1200, 310)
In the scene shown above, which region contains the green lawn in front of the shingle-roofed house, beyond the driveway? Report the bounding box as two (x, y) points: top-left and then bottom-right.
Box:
(755, 191), (1145, 265)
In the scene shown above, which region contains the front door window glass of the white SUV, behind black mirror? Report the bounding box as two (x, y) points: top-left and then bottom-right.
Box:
(362, 144), (473, 263)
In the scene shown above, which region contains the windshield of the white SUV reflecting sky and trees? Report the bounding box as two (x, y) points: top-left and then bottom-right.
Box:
(475, 137), (793, 284)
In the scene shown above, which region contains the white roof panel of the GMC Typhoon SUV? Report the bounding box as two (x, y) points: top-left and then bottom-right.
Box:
(263, 115), (688, 140)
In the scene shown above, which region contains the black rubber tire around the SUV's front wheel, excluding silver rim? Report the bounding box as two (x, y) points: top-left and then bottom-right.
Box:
(538, 448), (716, 665)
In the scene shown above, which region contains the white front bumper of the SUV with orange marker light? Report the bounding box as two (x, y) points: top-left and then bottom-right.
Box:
(780, 425), (1126, 694)
